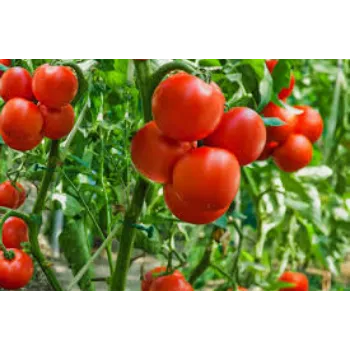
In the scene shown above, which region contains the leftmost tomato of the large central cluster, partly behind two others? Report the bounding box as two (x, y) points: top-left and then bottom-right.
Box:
(131, 121), (194, 184)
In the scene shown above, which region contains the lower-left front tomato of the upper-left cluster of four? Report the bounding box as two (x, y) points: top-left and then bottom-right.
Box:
(0, 98), (44, 139)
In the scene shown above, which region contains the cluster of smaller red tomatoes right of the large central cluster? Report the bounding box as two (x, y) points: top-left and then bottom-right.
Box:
(259, 60), (323, 172)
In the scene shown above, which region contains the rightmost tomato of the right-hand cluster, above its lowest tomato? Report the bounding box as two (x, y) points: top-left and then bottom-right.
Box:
(295, 106), (323, 143)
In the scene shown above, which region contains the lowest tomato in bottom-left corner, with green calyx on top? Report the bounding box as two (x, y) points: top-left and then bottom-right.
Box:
(0, 249), (34, 290)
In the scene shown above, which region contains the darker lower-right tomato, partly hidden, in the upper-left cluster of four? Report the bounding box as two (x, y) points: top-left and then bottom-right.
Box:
(38, 104), (75, 140)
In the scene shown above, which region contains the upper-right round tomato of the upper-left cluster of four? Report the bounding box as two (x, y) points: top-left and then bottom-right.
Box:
(33, 64), (78, 108)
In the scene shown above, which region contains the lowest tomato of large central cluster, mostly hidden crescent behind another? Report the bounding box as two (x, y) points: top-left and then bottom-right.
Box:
(164, 184), (229, 225)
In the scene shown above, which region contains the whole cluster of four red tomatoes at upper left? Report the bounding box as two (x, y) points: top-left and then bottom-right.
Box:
(0, 59), (79, 151)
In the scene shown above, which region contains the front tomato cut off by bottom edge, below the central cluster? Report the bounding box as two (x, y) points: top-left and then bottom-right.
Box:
(149, 275), (194, 293)
